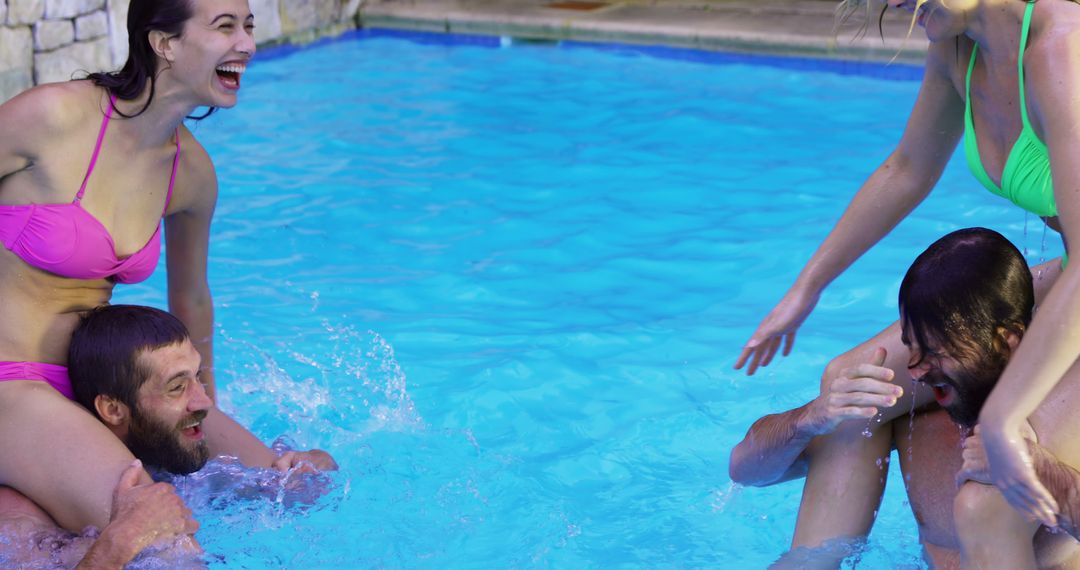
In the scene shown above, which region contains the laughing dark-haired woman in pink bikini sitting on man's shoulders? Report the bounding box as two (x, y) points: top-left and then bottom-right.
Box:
(0, 0), (333, 531)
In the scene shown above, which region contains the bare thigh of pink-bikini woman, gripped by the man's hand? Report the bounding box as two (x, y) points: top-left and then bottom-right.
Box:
(0, 381), (149, 532)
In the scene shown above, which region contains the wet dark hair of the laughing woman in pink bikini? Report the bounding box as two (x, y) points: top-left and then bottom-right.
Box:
(86, 0), (214, 121)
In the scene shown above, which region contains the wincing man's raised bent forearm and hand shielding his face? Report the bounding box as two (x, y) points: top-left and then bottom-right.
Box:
(728, 349), (901, 487)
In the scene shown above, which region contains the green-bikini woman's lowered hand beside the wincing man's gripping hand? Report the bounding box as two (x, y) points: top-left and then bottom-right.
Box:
(981, 422), (1058, 528)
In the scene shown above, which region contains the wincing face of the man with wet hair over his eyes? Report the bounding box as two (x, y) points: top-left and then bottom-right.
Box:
(904, 338), (1009, 428)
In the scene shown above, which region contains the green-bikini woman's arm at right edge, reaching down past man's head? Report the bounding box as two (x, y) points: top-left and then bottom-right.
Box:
(980, 30), (1080, 525)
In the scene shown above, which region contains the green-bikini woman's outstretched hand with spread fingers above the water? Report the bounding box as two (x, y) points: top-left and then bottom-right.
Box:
(735, 286), (821, 376)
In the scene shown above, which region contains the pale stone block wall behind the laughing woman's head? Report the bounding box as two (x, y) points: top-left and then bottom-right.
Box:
(0, 0), (364, 101)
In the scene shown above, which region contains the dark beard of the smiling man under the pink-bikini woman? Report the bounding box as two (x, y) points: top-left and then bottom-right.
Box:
(124, 406), (210, 475)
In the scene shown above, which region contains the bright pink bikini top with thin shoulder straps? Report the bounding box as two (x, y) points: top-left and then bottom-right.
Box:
(0, 97), (180, 283)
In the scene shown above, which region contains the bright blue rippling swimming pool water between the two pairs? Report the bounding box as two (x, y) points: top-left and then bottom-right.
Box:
(117, 33), (1061, 569)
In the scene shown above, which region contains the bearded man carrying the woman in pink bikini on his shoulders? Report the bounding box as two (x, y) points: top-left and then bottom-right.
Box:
(0, 306), (337, 569)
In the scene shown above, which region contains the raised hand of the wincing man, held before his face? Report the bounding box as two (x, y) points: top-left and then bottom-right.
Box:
(799, 348), (904, 435)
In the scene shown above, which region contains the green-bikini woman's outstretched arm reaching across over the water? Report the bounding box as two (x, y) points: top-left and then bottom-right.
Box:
(735, 42), (963, 375)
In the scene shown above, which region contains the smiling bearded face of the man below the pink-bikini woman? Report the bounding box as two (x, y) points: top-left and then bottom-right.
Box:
(124, 339), (213, 474)
